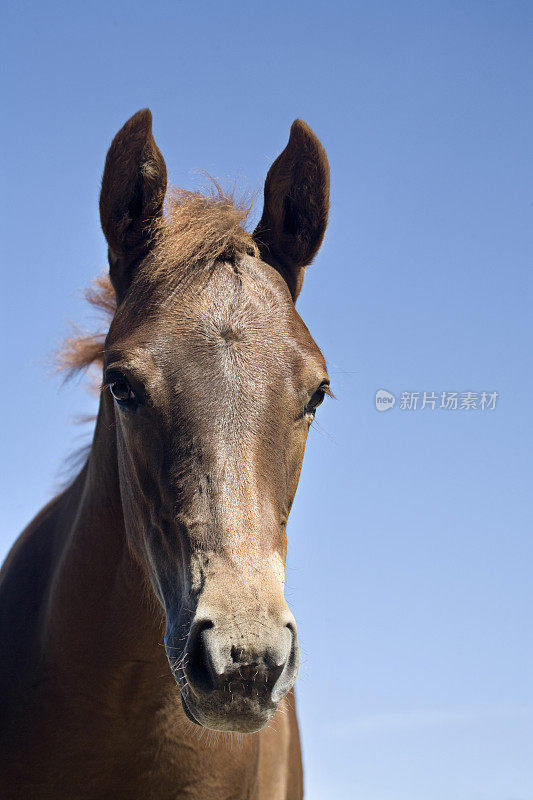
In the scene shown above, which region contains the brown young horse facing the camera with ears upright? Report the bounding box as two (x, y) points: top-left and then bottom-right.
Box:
(0, 110), (329, 800)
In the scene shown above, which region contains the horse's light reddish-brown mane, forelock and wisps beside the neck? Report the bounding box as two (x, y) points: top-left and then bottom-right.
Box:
(56, 184), (259, 377)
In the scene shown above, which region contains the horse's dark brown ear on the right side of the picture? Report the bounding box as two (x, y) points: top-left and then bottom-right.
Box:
(254, 119), (329, 300)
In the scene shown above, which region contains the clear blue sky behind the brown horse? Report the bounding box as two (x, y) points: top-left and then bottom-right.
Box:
(0, 0), (533, 800)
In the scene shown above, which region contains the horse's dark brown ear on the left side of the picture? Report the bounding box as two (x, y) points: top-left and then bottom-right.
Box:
(100, 108), (167, 299)
